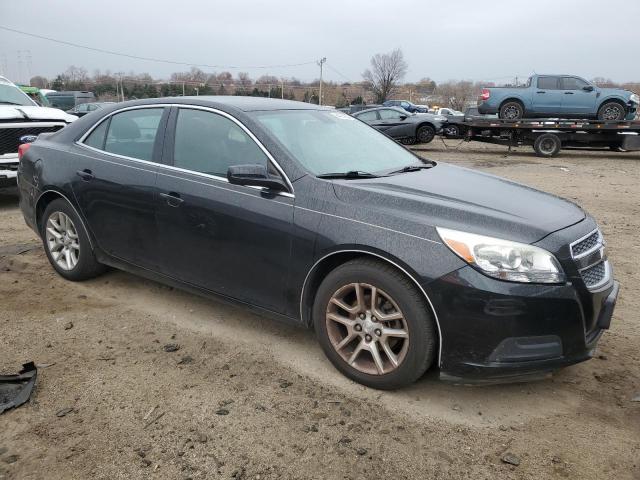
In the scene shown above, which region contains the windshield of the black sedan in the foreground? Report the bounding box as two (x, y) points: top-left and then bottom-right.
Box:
(253, 110), (420, 175)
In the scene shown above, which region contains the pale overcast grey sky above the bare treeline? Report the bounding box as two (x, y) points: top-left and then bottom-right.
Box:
(0, 0), (640, 82)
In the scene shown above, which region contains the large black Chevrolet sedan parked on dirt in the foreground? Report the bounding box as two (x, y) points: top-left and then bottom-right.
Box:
(18, 97), (618, 388)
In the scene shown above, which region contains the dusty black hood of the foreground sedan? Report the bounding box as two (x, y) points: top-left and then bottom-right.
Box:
(334, 163), (585, 243)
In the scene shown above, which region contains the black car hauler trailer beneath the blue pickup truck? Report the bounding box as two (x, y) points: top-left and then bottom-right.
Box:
(444, 119), (640, 157)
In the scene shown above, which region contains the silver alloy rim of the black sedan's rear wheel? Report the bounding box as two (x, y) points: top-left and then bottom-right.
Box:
(46, 212), (80, 271)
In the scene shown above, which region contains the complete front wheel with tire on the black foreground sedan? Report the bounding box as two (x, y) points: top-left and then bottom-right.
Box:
(313, 258), (437, 390)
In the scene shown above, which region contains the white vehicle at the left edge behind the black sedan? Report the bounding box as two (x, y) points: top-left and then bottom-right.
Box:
(0, 77), (77, 188)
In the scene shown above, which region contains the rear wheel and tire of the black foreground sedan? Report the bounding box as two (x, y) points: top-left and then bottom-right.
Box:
(40, 198), (106, 282)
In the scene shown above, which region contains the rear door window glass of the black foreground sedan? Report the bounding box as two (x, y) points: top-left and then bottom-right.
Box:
(104, 108), (164, 161)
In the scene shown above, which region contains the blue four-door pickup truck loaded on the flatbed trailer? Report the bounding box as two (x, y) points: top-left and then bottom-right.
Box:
(478, 75), (640, 121)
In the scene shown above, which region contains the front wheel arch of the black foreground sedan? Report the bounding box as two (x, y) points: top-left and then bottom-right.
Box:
(300, 246), (442, 366)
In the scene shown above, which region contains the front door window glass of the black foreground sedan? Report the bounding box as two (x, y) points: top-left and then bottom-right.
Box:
(173, 108), (270, 178)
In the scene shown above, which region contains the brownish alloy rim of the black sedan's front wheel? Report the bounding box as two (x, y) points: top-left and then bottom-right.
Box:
(326, 283), (409, 375)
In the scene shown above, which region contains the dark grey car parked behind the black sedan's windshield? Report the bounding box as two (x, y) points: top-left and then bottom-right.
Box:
(353, 107), (447, 145)
